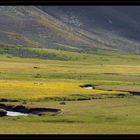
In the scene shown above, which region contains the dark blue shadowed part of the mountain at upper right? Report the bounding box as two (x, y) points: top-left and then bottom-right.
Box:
(38, 6), (140, 40)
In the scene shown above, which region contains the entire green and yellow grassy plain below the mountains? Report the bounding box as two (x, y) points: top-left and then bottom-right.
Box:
(0, 48), (140, 134)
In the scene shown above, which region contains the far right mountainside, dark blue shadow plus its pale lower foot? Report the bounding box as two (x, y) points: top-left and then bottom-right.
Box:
(38, 6), (140, 53)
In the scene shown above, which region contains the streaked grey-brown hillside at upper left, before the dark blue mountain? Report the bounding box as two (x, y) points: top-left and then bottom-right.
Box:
(0, 6), (89, 50)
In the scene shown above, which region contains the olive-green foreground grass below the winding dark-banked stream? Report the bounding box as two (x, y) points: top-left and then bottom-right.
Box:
(0, 97), (140, 134)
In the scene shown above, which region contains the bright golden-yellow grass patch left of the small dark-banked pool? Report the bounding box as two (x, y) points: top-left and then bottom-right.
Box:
(0, 80), (123, 99)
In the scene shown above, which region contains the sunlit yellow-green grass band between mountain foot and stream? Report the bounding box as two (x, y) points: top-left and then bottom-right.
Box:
(0, 50), (140, 99)
